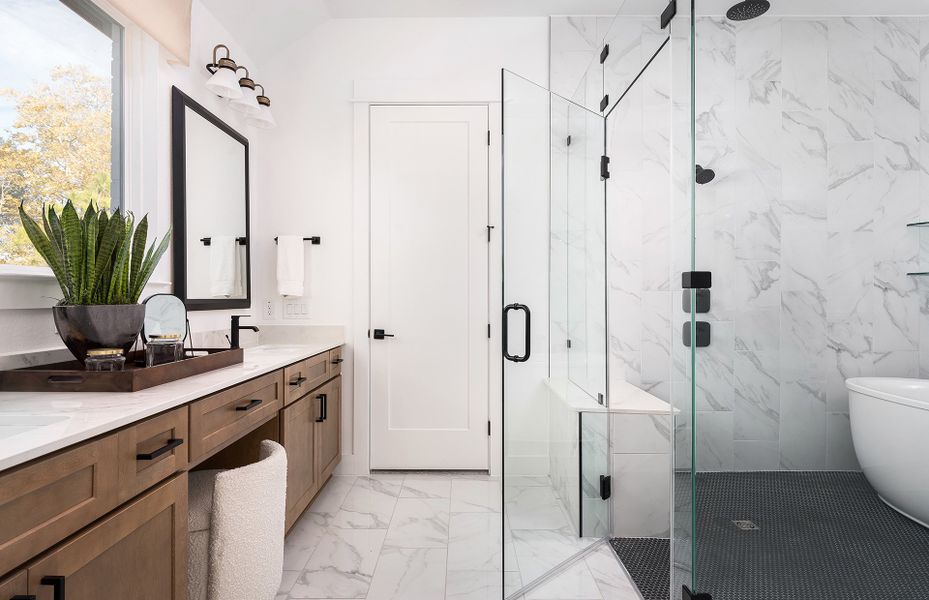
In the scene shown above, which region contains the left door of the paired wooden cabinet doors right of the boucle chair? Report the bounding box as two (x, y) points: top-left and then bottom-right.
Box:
(281, 394), (319, 529)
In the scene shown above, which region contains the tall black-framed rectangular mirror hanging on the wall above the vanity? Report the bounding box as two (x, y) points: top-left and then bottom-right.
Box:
(171, 88), (251, 310)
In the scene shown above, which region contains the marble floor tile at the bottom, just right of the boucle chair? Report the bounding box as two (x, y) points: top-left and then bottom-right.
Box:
(290, 527), (387, 598)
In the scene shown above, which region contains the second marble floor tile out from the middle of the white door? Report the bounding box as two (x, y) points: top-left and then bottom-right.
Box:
(385, 498), (449, 548)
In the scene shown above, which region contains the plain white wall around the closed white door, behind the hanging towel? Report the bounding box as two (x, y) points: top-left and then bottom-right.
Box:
(253, 18), (548, 468)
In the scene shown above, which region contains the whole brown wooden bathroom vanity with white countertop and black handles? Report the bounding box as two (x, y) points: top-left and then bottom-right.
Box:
(0, 336), (343, 600)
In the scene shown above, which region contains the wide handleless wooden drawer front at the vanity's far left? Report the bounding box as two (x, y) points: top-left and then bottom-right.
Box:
(0, 435), (117, 573)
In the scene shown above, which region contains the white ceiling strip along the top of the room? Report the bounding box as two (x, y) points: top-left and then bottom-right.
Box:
(202, 0), (929, 62)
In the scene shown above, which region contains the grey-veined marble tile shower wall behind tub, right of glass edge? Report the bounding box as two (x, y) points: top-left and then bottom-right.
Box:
(675, 17), (929, 470)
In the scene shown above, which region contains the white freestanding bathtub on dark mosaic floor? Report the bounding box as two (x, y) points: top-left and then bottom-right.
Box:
(845, 377), (929, 527)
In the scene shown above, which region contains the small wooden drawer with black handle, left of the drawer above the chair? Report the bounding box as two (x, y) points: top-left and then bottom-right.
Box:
(116, 406), (190, 502)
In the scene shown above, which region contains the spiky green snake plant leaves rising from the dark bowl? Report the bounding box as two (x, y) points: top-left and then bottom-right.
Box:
(19, 200), (171, 305)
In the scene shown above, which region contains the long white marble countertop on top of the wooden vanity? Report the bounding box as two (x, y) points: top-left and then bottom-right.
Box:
(0, 331), (345, 471)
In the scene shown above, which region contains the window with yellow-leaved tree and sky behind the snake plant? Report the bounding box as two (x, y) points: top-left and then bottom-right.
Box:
(0, 0), (123, 266)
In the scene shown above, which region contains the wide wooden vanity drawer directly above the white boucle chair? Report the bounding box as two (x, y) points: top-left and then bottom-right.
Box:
(190, 371), (284, 463)
